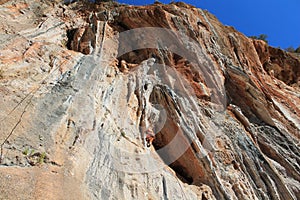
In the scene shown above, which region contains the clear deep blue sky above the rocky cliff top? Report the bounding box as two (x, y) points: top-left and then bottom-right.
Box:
(117, 0), (300, 49)
